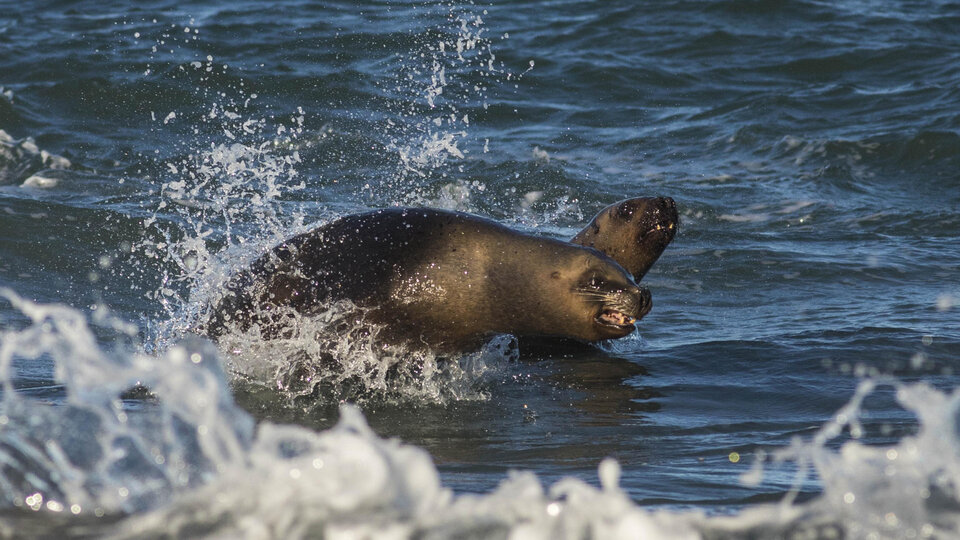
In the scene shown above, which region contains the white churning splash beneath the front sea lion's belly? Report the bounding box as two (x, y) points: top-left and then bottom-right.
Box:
(213, 301), (506, 409)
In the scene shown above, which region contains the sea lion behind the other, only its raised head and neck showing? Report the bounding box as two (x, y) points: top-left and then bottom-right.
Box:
(570, 197), (679, 283)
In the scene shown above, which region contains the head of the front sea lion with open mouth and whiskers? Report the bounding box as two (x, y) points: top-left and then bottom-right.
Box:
(552, 249), (653, 341)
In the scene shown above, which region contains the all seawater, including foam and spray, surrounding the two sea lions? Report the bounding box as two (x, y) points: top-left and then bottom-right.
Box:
(0, 0), (960, 539)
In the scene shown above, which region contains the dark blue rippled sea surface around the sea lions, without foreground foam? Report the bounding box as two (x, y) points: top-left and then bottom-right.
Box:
(0, 0), (960, 536)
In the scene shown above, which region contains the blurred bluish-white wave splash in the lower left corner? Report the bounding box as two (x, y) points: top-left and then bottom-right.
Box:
(0, 290), (253, 516)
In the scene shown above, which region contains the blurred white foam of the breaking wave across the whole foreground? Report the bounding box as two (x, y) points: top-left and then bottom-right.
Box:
(0, 290), (960, 539)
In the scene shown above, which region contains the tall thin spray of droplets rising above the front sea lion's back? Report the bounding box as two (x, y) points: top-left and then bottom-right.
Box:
(372, 2), (533, 215)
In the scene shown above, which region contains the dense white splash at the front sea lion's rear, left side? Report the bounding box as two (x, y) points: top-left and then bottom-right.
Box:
(134, 131), (304, 345)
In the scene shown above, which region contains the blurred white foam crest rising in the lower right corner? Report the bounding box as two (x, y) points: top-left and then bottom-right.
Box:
(724, 379), (960, 539)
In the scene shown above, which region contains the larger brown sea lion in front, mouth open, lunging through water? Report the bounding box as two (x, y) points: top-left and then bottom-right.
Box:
(205, 208), (651, 350)
